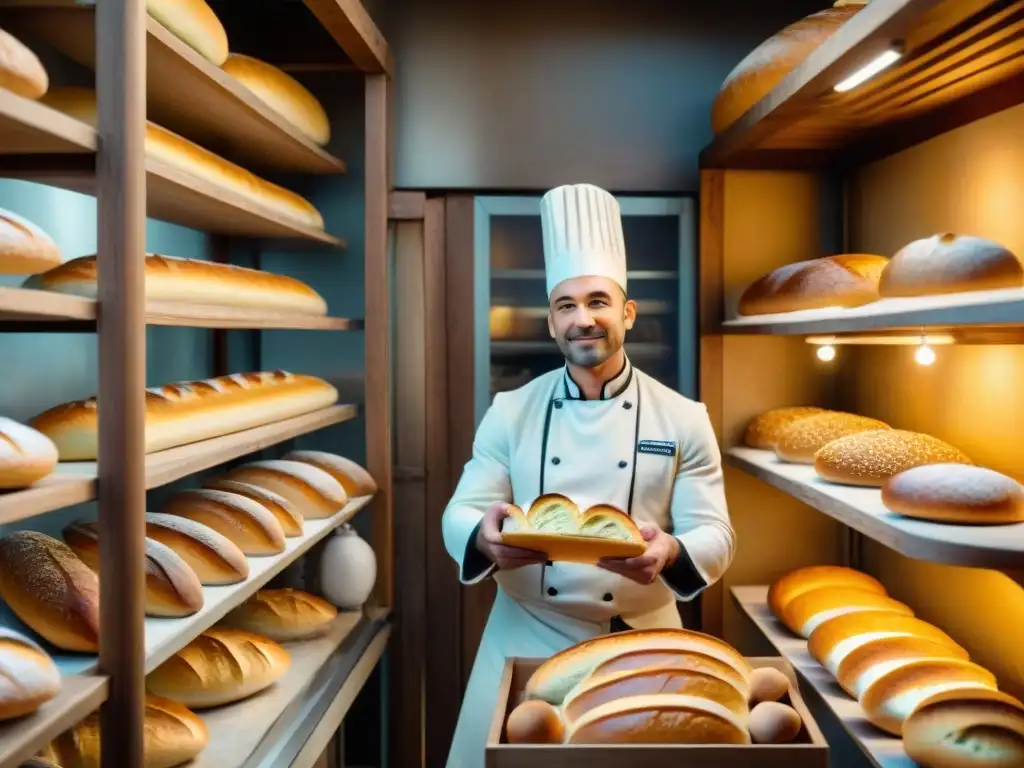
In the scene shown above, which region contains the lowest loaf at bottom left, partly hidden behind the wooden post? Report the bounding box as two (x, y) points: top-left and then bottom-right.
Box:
(42, 693), (210, 768)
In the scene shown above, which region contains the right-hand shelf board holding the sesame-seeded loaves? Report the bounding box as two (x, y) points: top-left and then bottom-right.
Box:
(727, 447), (1024, 568)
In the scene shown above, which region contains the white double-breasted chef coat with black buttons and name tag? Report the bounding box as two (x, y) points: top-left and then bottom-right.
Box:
(442, 359), (734, 768)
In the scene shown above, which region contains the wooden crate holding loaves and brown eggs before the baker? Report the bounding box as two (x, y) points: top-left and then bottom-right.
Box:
(486, 656), (828, 768)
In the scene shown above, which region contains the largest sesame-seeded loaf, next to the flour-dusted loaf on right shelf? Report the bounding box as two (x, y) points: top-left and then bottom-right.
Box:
(814, 429), (972, 487)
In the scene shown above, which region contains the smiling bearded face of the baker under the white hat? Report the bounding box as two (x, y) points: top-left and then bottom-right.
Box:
(548, 278), (636, 368)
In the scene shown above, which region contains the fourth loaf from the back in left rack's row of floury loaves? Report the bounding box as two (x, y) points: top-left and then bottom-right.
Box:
(163, 488), (285, 557)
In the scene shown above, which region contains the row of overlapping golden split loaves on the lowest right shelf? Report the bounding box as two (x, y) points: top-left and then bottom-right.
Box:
(768, 565), (1024, 768)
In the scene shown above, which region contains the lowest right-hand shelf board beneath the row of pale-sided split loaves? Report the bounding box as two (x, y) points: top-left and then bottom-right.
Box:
(730, 587), (918, 768)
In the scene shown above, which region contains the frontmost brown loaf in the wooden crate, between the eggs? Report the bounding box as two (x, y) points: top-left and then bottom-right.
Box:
(565, 693), (751, 744)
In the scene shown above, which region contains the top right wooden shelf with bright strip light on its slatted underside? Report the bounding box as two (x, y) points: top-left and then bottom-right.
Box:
(700, 0), (1024, 168)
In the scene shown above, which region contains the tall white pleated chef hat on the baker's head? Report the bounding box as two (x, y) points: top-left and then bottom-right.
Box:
(541, 184), (626, 298)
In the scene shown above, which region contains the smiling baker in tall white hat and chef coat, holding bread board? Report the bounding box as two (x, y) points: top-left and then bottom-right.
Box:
(441, 184), (734, 768)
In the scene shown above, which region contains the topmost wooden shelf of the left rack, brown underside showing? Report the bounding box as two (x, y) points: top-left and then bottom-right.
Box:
(0, 6), (346, 174)
